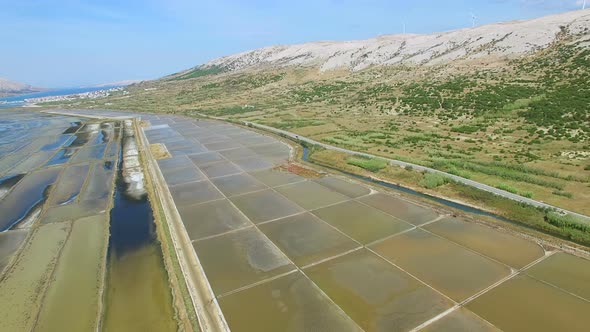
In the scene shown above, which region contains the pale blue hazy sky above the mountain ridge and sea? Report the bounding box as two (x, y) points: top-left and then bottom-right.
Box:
(0, 0), (590, 88)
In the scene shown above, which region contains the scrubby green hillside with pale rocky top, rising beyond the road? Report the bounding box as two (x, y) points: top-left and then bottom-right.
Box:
(48, 11), (590, 215)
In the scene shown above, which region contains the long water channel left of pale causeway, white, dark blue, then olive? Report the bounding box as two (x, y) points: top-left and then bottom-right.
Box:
(102, 121), (178, 331)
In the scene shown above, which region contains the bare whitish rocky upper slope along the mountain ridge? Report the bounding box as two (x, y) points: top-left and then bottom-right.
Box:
(200, 9), (590, 71)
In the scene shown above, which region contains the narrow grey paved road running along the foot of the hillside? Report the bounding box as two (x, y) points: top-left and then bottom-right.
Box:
(199, 113), (590, 223)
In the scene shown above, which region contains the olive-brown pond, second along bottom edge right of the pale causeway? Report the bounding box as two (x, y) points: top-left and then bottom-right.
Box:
(305, 249), (452, 331)
